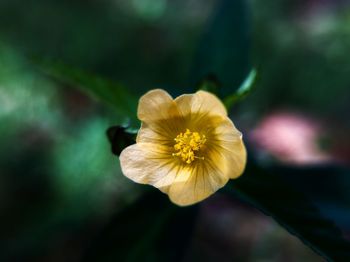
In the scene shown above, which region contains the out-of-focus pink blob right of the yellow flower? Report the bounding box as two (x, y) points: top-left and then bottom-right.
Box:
(250, 112), (330, 165)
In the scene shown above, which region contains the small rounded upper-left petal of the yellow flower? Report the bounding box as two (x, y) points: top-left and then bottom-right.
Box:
(137, 89), (179, 122)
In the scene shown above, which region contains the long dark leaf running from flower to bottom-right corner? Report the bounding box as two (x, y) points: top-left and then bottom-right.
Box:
(230, 161), (350, 261)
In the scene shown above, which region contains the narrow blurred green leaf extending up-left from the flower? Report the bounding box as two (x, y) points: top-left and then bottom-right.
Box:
(34, 59), (138, 123)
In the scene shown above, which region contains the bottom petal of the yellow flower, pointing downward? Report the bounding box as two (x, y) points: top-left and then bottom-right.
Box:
(168, 160), (228, 206)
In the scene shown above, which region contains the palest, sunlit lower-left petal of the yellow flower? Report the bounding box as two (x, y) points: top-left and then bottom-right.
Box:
(119, 143), (177, 191)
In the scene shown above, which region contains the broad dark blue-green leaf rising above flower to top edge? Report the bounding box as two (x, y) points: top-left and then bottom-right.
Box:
(191, 0), (251, 97)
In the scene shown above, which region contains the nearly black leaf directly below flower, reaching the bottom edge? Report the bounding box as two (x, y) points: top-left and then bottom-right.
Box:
(82, 188), (198, 261)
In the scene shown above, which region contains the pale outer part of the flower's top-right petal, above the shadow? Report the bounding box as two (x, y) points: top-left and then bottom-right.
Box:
(175, 91), (227, 116)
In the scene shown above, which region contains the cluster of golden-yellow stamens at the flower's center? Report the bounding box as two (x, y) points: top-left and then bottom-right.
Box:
(173, 129), (207, 164)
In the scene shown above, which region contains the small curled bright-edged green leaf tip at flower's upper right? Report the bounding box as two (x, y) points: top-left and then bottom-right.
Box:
(224, 69), (257, 110)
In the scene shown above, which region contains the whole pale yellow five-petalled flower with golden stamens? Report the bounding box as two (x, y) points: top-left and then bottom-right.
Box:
(120, 89), (246, 206)
